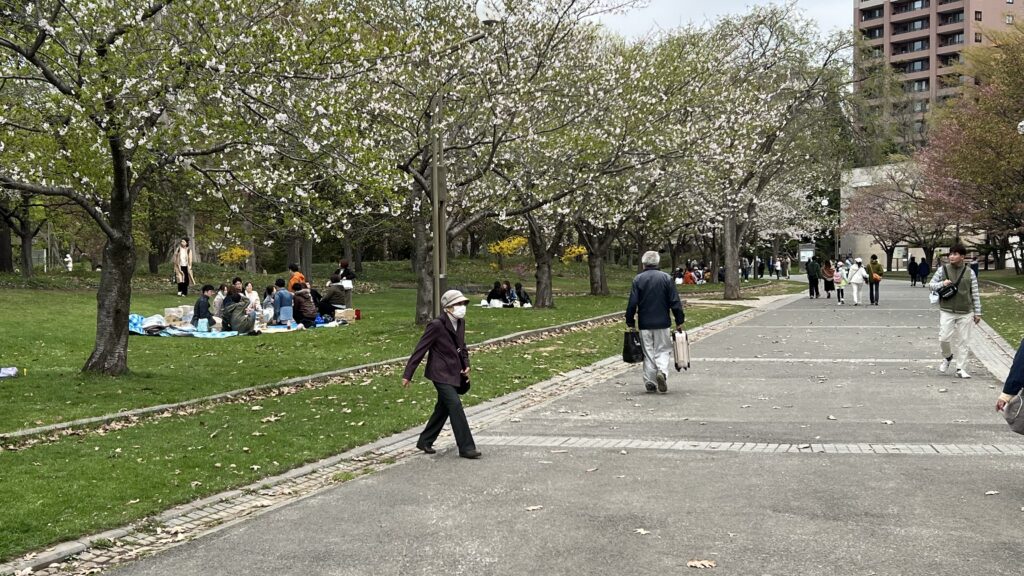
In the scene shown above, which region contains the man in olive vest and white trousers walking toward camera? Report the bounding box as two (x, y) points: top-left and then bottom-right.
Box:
(929, 244), (981, 378)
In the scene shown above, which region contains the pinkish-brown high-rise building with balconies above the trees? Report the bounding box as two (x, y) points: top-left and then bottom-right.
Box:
(853, 0), (1024, 119)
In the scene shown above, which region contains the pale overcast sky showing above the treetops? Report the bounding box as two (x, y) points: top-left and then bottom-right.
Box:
(601, 0), (853, 38)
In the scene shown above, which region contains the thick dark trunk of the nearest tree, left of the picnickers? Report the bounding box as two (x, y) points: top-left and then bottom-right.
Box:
(82, 234), (135, 376)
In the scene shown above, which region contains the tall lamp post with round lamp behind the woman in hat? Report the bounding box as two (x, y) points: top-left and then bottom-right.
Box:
(430, 0), (504, 318)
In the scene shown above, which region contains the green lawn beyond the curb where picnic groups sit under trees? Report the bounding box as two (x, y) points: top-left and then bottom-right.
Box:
(0, 260), (782, 433)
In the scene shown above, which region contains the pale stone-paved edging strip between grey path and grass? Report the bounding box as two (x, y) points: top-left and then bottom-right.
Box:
(0, 295), (799, 576)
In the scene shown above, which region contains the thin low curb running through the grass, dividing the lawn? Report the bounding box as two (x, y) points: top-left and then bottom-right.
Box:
(0, 311), (625, 442)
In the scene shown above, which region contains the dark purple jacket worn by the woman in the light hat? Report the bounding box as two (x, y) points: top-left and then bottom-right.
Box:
(401, 314), (469, 387)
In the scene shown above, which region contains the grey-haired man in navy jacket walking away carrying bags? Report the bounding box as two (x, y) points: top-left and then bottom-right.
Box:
(626, 251), (685, 394)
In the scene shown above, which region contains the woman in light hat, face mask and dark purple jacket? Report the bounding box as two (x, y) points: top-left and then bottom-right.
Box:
(401, 290), (480, 458)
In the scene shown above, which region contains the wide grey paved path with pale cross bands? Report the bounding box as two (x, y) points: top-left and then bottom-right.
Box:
(113, 281), (1024, 576)
